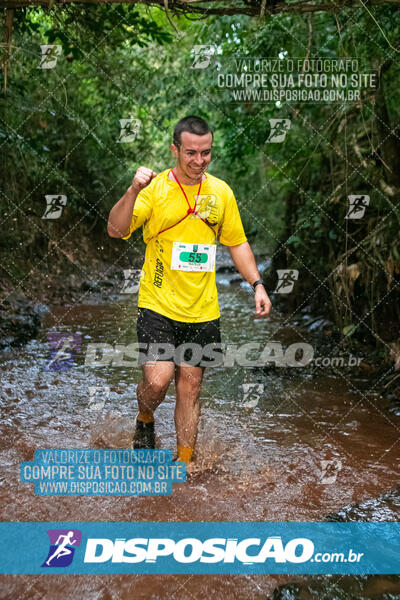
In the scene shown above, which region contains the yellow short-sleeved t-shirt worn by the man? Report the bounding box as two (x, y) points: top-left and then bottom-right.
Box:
(123, 169), (247, 323)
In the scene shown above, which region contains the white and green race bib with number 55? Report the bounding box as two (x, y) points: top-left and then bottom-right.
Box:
(171, 242), (217, 271)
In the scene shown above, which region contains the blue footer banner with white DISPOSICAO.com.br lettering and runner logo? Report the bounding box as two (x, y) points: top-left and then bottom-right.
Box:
(0, 522), (400, 574)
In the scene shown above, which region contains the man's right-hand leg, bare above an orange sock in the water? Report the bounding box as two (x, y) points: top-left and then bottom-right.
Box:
(175, 365), (204, 463)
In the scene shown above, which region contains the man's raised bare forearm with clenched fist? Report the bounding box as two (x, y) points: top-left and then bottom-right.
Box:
(107, 167), (157, 238)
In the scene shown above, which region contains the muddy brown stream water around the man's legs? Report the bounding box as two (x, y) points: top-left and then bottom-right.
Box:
(0, 255), (400, 600)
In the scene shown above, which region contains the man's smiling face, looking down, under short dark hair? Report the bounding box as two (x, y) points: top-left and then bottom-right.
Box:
(171, 131), (212, 181)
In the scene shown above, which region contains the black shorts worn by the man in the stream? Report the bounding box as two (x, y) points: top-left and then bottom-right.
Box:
(137, 308), (222, 367)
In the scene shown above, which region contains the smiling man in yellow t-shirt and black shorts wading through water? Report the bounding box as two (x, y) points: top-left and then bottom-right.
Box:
(107, 116), (271, 463)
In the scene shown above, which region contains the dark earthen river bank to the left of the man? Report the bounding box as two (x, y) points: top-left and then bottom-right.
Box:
(0, 230), (143, 350)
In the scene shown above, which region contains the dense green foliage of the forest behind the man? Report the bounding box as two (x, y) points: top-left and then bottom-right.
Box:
(0, 4), (400, 349)
